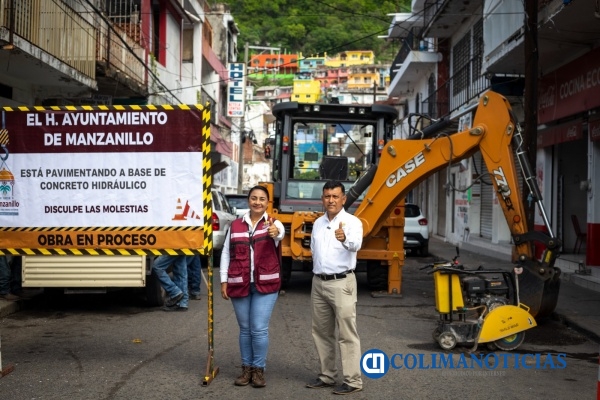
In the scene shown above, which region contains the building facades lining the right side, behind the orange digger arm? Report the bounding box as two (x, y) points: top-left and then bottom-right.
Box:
(387, 0), (600, 273)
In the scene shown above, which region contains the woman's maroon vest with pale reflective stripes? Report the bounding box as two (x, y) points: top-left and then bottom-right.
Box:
(227, 218), (281, 297)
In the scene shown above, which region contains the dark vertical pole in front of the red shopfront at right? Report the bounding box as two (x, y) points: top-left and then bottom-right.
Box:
(522, 0), (539, 229)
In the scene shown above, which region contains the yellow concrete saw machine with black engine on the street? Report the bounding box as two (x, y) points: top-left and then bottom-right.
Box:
(421, 248), (537, 351)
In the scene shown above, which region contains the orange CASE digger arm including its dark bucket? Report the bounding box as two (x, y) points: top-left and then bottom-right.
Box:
(354, 91), (560, 316)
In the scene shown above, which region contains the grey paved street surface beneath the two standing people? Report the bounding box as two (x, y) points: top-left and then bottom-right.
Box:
(0, 257), (598, 400)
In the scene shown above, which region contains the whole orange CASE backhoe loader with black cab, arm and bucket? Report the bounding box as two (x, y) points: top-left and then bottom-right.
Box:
(263, 91), (560, 317)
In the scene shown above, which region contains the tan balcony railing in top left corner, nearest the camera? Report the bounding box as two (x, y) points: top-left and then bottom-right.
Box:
(0, 0), (96, 79)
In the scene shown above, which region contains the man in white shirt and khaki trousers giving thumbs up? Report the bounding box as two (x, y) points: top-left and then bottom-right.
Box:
(306, 181), (363, 394)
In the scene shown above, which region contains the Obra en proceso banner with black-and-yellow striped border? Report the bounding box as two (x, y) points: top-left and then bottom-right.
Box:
(0, 105), (212, 254)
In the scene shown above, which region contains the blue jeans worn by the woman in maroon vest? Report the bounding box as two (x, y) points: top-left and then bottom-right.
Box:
(231, 283), (279, 368)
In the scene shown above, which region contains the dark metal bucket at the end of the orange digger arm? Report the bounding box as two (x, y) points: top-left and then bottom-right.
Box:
(519, 268), (560, 319)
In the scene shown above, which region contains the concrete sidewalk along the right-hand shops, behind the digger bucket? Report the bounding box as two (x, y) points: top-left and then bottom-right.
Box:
(429, 237), (600, 343)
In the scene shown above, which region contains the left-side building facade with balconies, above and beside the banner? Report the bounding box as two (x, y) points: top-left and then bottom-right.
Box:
(0, 0), (239, 194)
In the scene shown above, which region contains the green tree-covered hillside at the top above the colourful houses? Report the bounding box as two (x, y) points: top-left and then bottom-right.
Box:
(229, 0), (410, 62)
